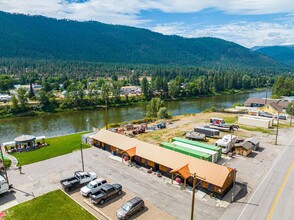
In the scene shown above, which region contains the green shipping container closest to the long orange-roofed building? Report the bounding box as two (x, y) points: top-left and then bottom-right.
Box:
(160, 142), (212, 162)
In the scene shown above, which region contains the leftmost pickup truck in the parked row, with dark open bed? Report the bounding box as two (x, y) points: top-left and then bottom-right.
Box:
(60, 171), (96, 191)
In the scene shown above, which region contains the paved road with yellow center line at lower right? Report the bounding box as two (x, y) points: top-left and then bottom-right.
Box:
(238, 133), (294, 220)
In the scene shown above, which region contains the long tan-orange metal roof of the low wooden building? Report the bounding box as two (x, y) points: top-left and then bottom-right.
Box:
(92, 130), (233, 187)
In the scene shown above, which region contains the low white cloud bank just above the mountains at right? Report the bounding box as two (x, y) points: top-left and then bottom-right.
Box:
(151, 21), (294, 48)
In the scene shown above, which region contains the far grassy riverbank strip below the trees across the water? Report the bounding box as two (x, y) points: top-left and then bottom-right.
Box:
(0, 88), (267, 119)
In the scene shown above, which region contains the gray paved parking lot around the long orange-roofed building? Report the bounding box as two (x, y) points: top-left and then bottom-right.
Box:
(2, 126), (293, 219)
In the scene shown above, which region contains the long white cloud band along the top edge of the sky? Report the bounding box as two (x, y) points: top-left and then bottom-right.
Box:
(0, 0), (294, 25)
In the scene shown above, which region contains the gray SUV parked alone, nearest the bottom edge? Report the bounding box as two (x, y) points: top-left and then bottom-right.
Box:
(116, 197), (144, 219)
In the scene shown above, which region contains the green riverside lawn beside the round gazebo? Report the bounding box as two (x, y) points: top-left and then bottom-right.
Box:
(12, 132), (89, 166)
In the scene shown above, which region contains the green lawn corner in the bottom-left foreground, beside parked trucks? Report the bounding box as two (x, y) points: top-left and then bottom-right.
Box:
(4, 190), (96, 220)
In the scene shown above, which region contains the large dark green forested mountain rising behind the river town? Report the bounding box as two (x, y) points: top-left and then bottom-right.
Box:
(0, 12), (283, 68)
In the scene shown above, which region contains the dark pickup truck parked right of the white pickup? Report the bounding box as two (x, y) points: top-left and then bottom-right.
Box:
(91, 184), (122, 205)
